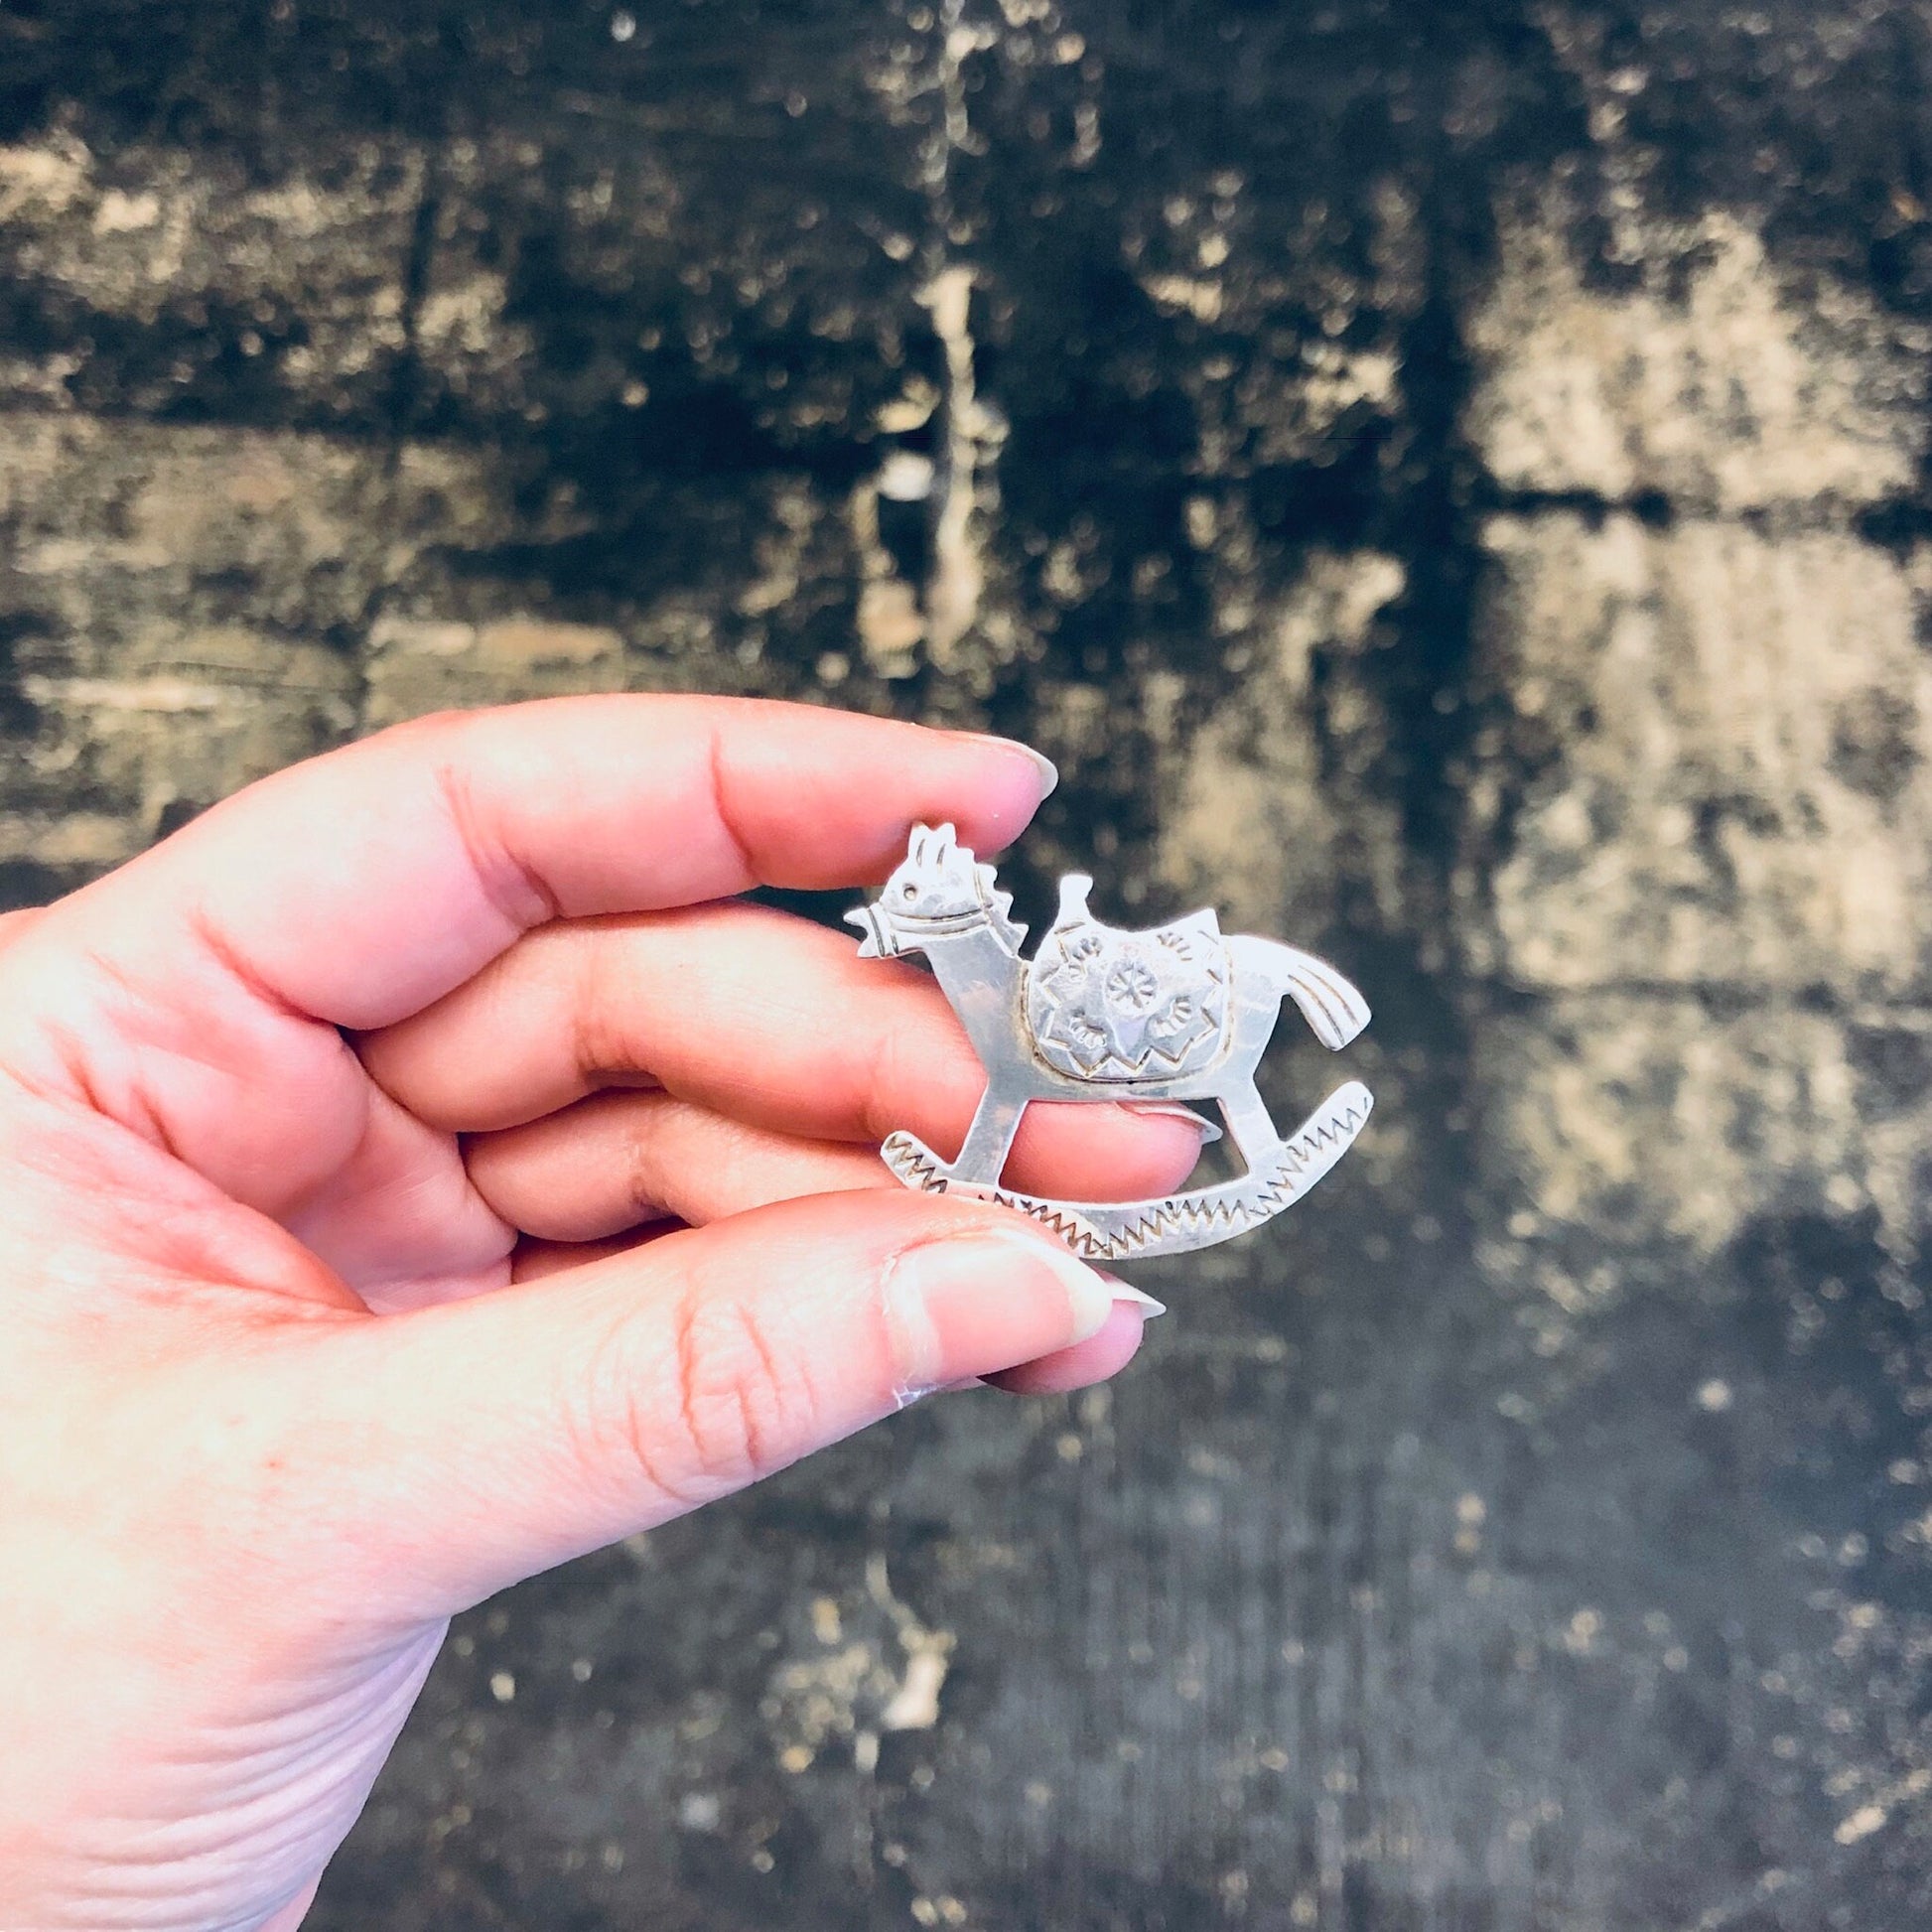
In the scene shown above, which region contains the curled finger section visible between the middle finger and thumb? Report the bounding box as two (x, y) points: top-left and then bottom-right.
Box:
(466, 1093), (898, 1242)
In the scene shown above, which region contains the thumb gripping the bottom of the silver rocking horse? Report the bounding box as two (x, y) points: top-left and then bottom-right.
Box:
(282, 1190), (1113, 1619)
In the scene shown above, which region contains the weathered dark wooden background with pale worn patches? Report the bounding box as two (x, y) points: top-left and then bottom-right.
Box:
(0, 0), (1932, 1932)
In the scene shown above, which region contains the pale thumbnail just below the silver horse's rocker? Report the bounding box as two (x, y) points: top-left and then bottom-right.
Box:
(885, 1229), (1115, 1397)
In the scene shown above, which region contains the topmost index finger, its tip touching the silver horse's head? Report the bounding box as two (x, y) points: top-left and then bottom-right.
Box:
(22, 696), (1053, 1030)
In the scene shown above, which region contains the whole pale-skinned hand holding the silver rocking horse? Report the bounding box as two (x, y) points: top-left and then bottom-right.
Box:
(0, 698), (1198, 1932)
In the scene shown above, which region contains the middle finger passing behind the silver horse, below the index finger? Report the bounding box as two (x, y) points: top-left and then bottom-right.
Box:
(359, 904), (1205, 1199)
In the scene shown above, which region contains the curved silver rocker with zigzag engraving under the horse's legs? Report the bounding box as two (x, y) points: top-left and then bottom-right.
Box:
(879, 1080), (1376, 1262)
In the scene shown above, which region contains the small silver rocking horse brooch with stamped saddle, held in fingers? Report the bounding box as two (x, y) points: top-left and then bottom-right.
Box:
(846, 825), (1374, 1262)
